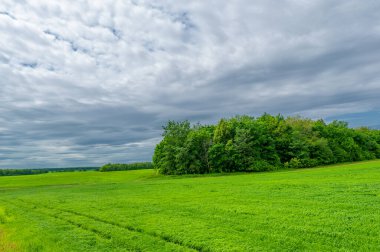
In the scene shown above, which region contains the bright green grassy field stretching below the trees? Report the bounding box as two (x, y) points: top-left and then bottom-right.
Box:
(0, 160), (380, 251)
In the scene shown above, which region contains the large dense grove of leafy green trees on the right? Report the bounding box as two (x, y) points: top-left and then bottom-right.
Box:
(153, 114), (380, 174)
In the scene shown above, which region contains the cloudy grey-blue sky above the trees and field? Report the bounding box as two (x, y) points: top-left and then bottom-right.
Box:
(0, 0), (380, 168)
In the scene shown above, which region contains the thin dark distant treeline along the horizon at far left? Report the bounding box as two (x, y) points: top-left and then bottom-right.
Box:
(0, 167), (99, 176)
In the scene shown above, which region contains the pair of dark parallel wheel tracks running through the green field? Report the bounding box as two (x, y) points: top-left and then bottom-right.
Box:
(14, 199), (205, 252)
